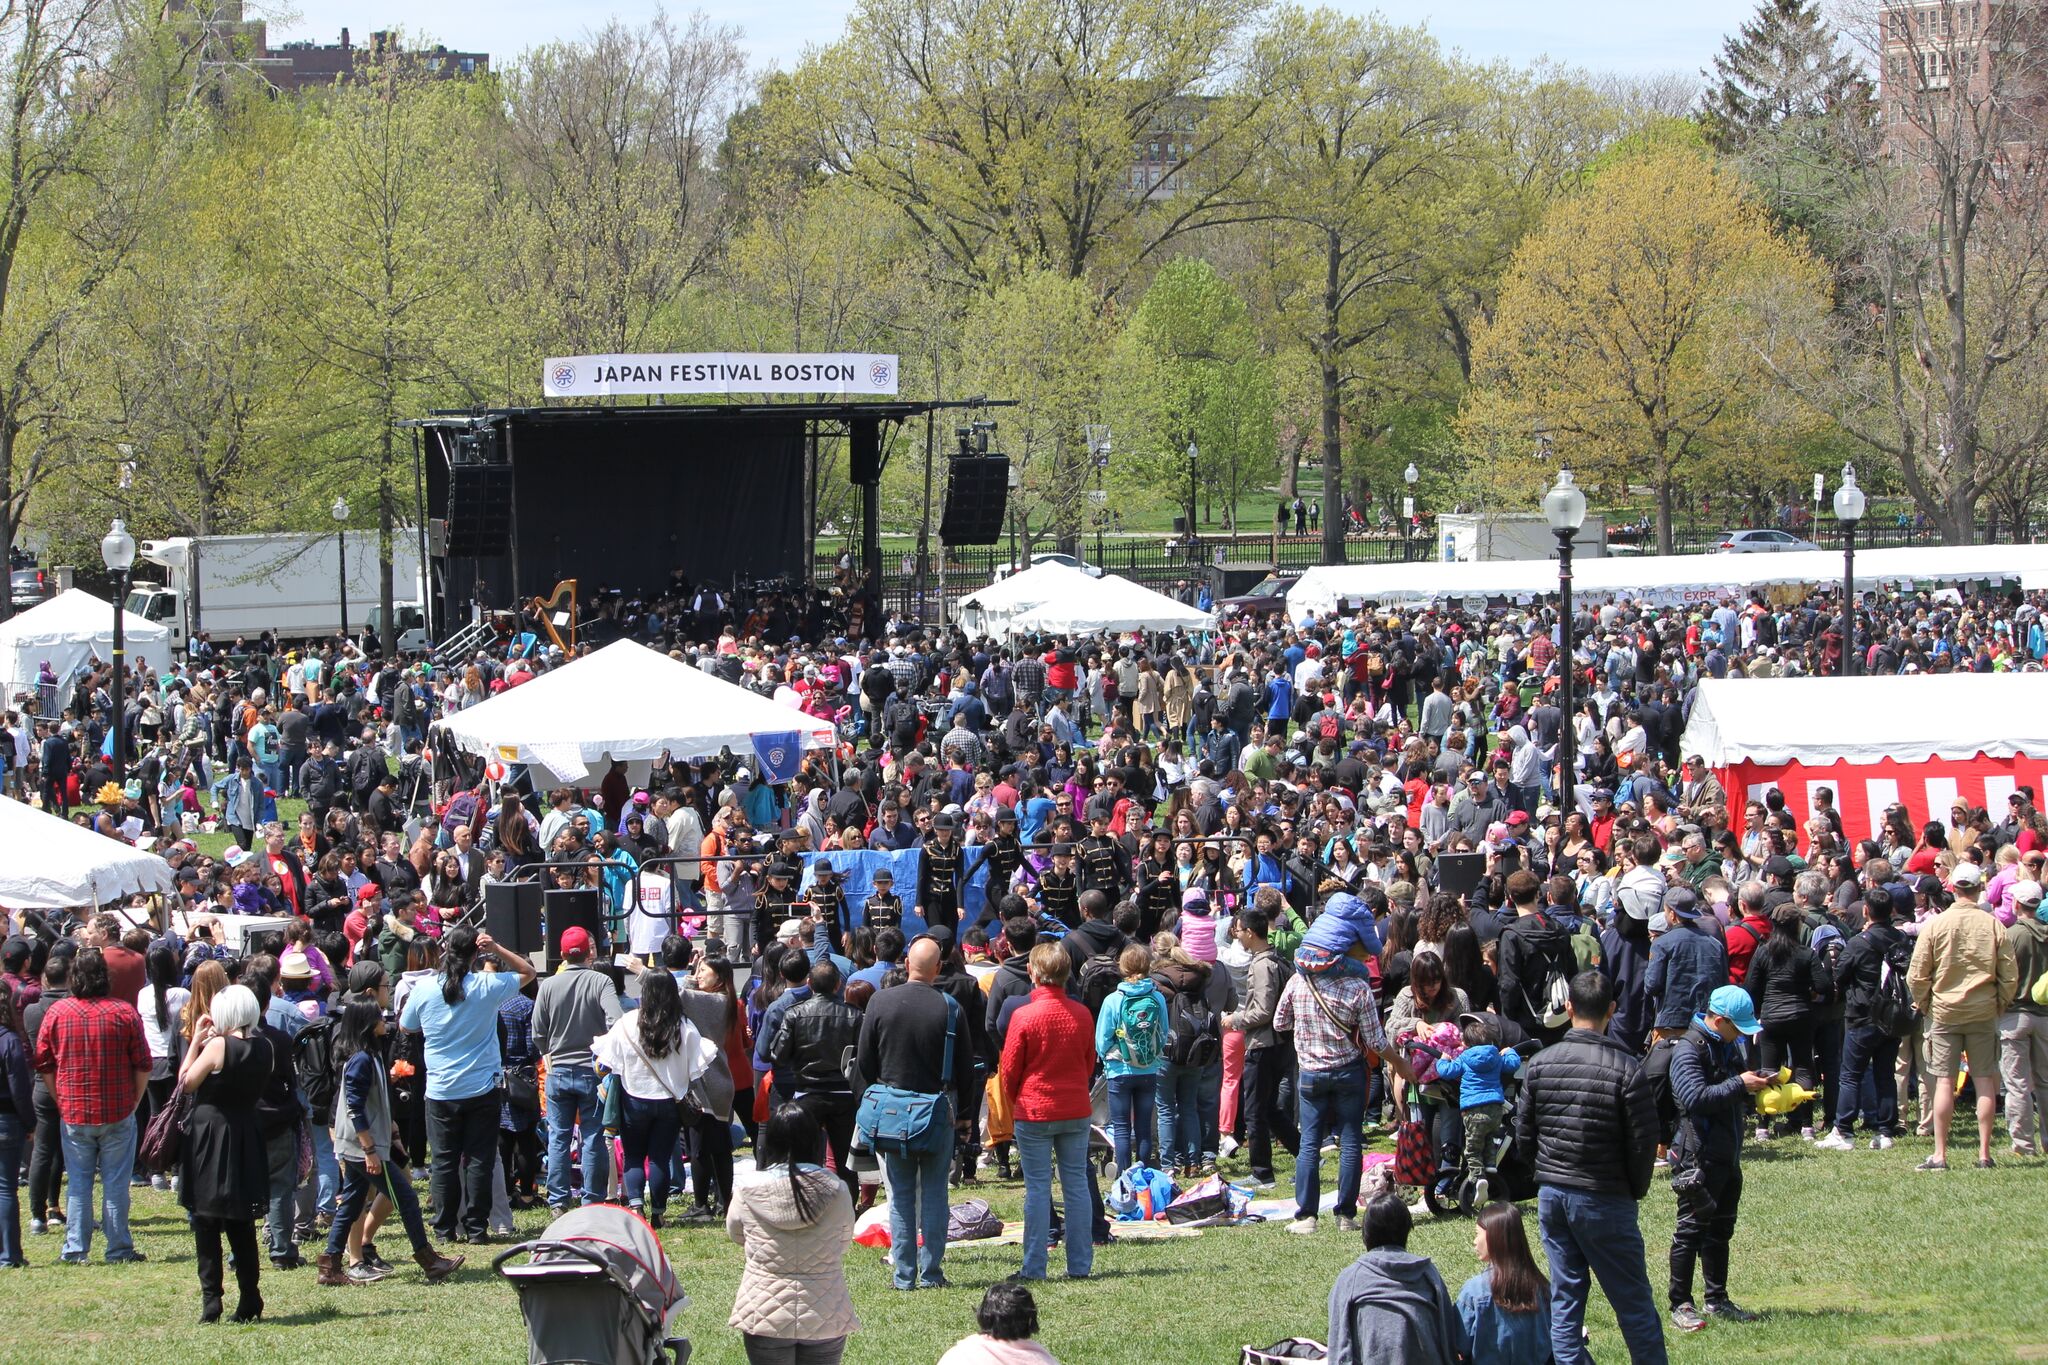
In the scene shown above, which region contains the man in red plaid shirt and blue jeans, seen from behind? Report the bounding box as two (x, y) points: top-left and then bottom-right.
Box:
(35, 948), (150, 1265)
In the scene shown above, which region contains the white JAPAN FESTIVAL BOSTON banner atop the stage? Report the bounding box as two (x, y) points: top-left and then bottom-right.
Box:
(541, 350), (897, 399)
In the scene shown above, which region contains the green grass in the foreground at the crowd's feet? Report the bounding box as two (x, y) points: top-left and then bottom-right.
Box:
(19, 1126), (2048, 1365)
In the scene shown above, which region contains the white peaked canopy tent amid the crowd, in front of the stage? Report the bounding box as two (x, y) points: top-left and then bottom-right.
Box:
(440, 641), (836, 782)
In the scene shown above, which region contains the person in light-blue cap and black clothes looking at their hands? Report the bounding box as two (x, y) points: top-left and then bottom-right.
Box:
(1669, 986), (1776, 1332)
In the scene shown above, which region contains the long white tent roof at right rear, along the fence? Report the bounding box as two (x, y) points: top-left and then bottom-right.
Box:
(1288, 544), (2048, 618)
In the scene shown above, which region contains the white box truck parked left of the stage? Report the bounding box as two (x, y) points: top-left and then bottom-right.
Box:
(127, 528), (426, 649)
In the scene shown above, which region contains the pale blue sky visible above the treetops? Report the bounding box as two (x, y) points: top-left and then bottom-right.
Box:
(272, 0), (1755, 76)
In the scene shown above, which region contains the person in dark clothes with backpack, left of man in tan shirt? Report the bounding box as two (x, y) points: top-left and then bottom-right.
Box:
(1815, 886), (1919, 1152)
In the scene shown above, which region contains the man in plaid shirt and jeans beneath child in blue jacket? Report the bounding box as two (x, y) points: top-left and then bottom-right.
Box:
(1274, 960), (1413, 1236)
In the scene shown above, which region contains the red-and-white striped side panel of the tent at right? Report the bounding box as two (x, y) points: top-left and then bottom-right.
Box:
(1716, 757), (2048, 853)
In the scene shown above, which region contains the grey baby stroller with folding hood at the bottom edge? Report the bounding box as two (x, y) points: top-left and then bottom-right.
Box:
(492, 1203), (690, 1365)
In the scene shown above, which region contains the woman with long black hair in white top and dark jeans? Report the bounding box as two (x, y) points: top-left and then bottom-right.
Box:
(590, 972), (717, 1228)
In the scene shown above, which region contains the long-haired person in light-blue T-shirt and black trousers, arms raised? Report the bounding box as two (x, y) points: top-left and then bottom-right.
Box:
(399, 925), (535, 1242)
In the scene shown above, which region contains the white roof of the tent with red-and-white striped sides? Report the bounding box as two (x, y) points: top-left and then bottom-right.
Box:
(1683, 673), (2048, 767)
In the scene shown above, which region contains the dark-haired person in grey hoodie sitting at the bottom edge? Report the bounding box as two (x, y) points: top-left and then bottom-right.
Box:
(1329, 1195), (1466, 1365)
